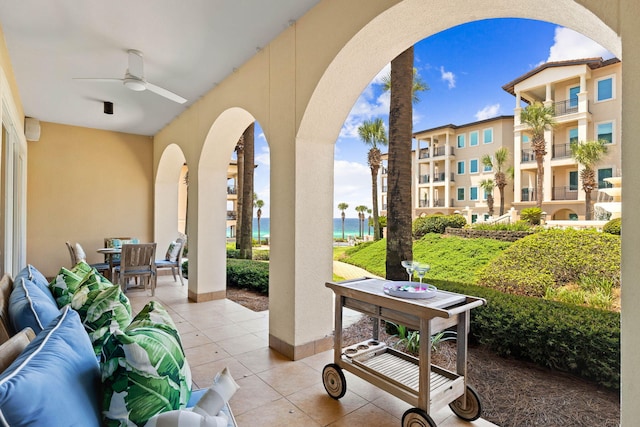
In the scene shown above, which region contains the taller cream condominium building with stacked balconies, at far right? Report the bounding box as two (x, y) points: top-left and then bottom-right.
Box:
(503, 58), (622, 220)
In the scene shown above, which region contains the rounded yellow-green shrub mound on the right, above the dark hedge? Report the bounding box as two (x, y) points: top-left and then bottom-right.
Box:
(476, 229), (621, 297)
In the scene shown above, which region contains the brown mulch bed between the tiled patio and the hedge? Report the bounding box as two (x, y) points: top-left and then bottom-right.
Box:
(227, 288), (620, 427)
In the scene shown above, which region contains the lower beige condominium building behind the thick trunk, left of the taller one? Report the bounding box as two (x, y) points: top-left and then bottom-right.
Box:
(381, 116), (513, 221)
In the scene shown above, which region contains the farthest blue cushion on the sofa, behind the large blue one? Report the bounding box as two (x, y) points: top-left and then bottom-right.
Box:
(9, 276), (60, 335)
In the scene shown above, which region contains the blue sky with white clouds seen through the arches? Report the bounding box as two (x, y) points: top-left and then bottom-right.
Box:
(248, 19), (612, 218)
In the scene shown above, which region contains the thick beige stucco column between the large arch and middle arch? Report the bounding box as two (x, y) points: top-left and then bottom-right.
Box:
(269, 136), (332, 360)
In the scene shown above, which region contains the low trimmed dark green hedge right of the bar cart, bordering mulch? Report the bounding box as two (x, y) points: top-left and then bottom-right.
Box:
(430, 280), (620, 389)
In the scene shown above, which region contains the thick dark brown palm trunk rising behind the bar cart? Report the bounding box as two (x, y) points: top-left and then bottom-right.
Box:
(386, 47), (413, 280)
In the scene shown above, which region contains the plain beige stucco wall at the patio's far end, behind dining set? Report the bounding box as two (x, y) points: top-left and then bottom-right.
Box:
(27, 122), (154, 276)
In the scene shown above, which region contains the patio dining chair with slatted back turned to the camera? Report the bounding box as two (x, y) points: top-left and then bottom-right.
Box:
(114, 243), (156, 296)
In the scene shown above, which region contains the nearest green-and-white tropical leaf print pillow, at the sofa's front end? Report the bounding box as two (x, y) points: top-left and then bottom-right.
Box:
(101, 301), (191, 427)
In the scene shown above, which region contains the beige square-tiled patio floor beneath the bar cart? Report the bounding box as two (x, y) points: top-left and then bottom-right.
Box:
(127, 275), (494, 427)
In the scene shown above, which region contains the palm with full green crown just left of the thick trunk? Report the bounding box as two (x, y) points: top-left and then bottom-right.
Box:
(358, 118), (388, 240)
